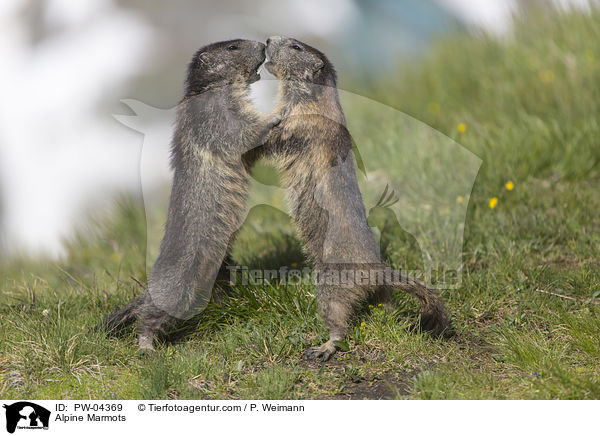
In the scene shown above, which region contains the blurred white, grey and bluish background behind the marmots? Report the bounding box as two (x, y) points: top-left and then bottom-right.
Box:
(0, 0), (589, 259)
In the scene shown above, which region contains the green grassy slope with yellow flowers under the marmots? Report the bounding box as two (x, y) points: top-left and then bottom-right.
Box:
(0, 10), (600, 399)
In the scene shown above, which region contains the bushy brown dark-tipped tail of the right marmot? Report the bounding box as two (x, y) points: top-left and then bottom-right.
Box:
(396, 276), (452, 336)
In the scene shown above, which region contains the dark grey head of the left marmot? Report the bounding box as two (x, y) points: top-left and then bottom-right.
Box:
(186, 39), (265, 94)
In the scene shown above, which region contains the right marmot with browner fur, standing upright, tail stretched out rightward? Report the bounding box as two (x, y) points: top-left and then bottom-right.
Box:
(258, 36), (449, 360)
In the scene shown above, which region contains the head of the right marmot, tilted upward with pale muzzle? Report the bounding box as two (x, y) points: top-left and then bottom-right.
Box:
(265, 36), (336, 86)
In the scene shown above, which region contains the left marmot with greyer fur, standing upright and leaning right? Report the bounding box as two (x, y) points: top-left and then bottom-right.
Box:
(102, 39), (278, 350)
